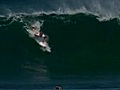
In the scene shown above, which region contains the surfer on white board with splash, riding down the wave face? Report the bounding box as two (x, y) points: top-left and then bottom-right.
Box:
(26, 22), (51, 52)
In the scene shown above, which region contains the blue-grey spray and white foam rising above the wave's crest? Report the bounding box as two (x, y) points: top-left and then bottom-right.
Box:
(0, 0), (120, 21)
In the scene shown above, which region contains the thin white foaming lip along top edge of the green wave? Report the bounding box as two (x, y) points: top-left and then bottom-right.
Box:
(0, 7), (120, 21)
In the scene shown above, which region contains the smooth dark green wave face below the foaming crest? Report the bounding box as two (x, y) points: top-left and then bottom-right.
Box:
(0, 13), (120, 89)
